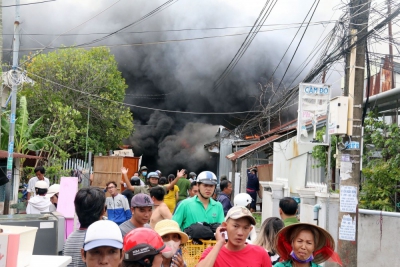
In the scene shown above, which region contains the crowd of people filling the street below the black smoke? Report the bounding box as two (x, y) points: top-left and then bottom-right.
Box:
(23, 166), (340, 267)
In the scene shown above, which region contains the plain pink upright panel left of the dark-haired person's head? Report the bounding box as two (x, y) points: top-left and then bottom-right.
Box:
(57, 177), (78, 219)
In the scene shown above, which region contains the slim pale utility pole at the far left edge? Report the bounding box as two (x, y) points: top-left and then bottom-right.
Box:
(3, 0), (20, 214)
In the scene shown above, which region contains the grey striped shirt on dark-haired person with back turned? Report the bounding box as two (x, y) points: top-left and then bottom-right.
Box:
(63, 230), (86, 267)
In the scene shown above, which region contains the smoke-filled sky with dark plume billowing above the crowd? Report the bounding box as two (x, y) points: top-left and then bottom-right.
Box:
(3, 0), (342, 173)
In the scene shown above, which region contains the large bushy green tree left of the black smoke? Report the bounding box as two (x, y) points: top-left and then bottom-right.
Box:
(20, 47), (133, 156)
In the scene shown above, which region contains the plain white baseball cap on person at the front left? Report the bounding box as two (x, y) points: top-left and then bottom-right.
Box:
(83, 220), (123, 251)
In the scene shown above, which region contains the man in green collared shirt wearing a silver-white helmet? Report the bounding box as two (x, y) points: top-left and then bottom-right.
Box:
(172, 171), (224, 230)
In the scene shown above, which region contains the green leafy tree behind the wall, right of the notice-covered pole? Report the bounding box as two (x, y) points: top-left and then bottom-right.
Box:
(360, 111), (400, 211)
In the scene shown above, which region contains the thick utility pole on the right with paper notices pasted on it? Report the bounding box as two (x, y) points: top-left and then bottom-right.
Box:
(337, 0), (370, 267)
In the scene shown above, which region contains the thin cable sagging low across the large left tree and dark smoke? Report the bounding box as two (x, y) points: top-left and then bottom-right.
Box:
(21, 69), (258, 115)
